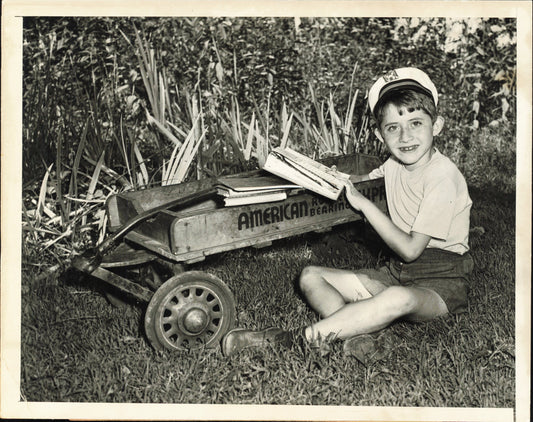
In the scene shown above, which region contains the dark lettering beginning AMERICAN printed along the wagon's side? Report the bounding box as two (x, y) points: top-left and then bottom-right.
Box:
(237, 186), (385, 230)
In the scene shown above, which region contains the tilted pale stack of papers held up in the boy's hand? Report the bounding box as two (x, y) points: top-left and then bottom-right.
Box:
(263, 148), (350, 200)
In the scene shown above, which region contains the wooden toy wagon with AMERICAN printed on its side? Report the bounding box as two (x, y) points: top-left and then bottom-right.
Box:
(72, 154), (386, 350)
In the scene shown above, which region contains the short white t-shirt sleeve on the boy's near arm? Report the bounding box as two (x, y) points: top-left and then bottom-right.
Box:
(411, 177), (457, 240)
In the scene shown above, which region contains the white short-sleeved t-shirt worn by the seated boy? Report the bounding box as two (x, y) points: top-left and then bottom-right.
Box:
(369, 149), (472, 255)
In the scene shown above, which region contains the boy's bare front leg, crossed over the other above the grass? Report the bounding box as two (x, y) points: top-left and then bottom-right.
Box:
(305, 286), (448, 341)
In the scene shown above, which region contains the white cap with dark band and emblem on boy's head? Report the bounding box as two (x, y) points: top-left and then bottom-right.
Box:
(368, 67), (439, 113)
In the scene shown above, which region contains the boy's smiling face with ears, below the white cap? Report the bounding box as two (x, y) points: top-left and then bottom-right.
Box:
(376, 104), (444, 170)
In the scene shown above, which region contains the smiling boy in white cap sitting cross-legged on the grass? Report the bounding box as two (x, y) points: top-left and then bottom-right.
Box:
(222, 68), (473, 362)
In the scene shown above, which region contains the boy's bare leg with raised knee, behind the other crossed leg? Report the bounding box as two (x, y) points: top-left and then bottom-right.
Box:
(300, 266), (387, 318)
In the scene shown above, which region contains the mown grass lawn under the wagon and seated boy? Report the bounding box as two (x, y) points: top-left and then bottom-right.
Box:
(21, 189), (515, 407)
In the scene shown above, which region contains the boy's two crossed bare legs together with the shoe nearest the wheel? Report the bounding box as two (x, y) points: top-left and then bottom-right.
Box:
(222, 267), (448, 357)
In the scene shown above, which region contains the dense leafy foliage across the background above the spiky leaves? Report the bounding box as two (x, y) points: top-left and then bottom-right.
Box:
(24, 18), (516, 173)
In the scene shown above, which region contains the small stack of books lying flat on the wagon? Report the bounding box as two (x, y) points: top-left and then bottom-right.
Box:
(217, 175), (302, 207)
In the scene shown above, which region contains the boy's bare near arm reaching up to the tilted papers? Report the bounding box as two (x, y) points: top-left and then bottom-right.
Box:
(346, 182), (431, 262)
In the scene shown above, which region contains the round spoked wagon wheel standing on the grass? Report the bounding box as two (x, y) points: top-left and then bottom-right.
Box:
(144, 271), (235, 350)
